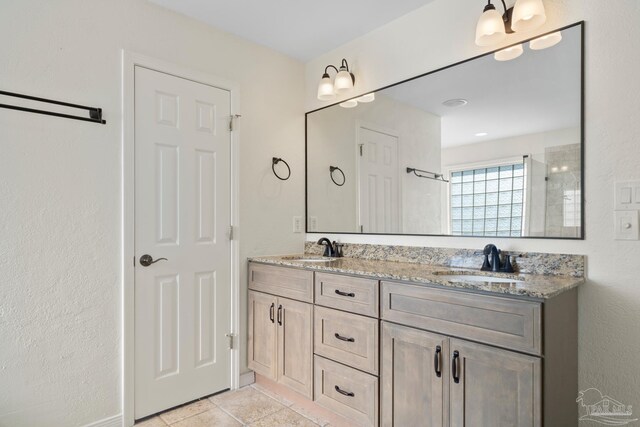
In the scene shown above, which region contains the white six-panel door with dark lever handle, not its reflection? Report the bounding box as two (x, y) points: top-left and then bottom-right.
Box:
(135, 67), (231, 419)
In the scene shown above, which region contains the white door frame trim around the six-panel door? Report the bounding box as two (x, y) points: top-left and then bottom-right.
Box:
(121, 49), (240, 426)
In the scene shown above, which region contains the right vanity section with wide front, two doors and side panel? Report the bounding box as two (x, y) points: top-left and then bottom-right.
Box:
(380, 282), (578, 427)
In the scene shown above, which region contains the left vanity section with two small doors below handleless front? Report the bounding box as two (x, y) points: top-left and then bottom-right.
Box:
(247, 265), (313, 399)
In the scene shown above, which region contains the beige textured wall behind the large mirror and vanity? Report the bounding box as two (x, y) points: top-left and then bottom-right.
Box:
(306, 0), (640, 408)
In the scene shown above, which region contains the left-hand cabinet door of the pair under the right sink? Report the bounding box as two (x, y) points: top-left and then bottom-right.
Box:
(381, 322), (448, 427)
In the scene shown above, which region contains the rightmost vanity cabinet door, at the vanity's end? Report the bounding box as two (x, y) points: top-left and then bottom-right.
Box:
(450, 339), (541, 427)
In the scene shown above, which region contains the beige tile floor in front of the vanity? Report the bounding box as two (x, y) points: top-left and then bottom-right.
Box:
(136, 384), (328, 427)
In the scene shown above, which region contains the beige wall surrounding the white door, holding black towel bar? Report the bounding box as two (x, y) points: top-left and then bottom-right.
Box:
(0, 0), (304, 427)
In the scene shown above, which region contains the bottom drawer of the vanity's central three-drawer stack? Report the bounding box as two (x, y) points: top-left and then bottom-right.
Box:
(314, 356), (378, 426)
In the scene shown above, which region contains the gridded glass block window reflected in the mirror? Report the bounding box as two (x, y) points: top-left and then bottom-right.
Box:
(449, 163), (525, 237)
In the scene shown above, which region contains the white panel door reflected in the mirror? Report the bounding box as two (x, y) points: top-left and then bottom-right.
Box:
(358, 127), (400, 233)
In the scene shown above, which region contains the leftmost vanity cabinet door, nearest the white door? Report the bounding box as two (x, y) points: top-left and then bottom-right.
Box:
(248, 291), (278, 380)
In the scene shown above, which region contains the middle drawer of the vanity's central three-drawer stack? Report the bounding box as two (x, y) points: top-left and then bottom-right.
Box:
(314, 307), (378, 375)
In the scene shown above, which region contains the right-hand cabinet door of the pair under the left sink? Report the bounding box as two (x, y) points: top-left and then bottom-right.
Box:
(276, 298), (313, 399)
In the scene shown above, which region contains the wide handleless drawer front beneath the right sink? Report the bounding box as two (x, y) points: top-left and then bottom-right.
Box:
(381, 282), (542, 355)
